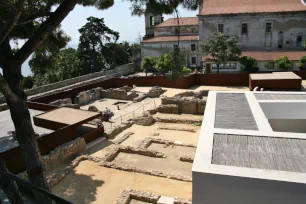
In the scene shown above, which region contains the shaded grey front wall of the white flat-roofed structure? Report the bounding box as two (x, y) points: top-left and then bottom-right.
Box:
(192, 172), (306, 204)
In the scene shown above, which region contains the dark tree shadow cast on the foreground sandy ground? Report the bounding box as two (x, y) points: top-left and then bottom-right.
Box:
(52, 172), (104, 204)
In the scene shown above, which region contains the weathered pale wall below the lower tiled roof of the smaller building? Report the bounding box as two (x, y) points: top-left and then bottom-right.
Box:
(141, 41), (202, 67)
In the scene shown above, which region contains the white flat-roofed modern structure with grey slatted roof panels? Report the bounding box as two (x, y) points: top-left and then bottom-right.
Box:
(192, 91), (306, 204)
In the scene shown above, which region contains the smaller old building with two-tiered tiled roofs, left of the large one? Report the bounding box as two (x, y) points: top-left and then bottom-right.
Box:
(141, 15), (202, 68)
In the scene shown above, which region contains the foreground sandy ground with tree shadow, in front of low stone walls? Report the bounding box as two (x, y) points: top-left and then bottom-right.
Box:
(52, 161), (192, 204)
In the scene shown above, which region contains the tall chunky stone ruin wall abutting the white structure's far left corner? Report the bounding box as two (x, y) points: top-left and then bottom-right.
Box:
(157, 91), (208, 115)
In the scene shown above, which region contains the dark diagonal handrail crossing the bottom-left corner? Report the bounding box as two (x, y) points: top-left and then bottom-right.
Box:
(0, 170), (72, 204)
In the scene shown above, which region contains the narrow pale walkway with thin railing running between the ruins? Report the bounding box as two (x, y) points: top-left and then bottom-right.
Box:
(110, 100), (157, 129)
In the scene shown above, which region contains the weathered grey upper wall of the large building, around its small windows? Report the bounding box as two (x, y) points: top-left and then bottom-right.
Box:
(199, 12), (306, 50)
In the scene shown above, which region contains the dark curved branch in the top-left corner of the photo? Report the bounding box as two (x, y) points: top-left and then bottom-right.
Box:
(0, 0), (25, 46)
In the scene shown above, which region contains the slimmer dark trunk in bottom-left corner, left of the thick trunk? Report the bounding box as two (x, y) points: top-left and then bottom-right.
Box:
(0, 159), (24, 204)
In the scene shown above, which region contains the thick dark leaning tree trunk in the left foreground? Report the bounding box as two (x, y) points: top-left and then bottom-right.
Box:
(3, 65), (52, 203)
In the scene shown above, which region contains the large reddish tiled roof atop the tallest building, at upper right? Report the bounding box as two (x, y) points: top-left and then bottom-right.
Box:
(199, 0), (306, 15)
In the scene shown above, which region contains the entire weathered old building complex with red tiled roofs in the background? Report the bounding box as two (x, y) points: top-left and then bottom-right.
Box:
(142, 0), (306, 72)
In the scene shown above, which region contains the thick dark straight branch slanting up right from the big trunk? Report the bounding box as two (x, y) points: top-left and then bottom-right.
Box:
(14, 0), (78, 65)
